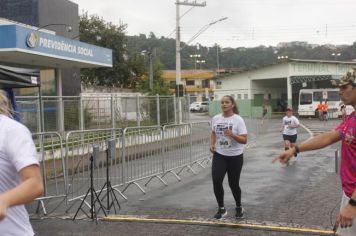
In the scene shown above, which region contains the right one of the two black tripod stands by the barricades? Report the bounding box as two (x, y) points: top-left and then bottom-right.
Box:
(98, 139), (121, 214)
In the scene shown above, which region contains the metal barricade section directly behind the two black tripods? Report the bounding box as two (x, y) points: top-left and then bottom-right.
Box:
(65, 129), (126, 204)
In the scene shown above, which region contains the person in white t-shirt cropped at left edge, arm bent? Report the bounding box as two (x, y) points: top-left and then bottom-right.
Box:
(0, 91), (43, 236)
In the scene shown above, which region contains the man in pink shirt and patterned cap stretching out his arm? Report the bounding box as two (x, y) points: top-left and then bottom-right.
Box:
(273, 69), (356, 236)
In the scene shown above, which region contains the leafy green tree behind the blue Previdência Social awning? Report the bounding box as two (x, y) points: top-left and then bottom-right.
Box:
(79, 12), (144, 88)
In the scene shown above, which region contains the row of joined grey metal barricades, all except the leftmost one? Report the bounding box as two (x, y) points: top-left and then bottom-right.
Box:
(65, 122), (210, 201)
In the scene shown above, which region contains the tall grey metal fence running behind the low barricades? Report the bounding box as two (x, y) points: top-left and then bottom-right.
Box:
(16, 94), (189, 134)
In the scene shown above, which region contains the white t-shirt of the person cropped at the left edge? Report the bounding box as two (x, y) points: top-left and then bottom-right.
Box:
(0, 115), (39, 236)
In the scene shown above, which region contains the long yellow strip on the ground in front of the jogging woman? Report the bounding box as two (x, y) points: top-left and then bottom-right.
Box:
(103, 216), (334, 235)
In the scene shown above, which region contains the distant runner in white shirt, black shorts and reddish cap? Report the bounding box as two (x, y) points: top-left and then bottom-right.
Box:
(280, 108), (299, 155)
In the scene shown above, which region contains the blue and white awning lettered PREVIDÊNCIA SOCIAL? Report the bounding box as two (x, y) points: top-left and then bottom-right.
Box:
(0, 24), (112, 69)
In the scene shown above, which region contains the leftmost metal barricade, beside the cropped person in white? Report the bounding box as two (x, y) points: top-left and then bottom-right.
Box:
(32, 132), (67, 215)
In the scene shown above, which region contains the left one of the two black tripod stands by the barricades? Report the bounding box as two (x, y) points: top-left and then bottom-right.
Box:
(73, 146), (106, 222)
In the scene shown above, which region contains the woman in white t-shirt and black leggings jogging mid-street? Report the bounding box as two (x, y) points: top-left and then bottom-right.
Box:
(210, 96), (247, 219)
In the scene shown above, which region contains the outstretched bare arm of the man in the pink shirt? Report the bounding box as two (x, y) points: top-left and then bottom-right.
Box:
(273, 130), (341, 164)
